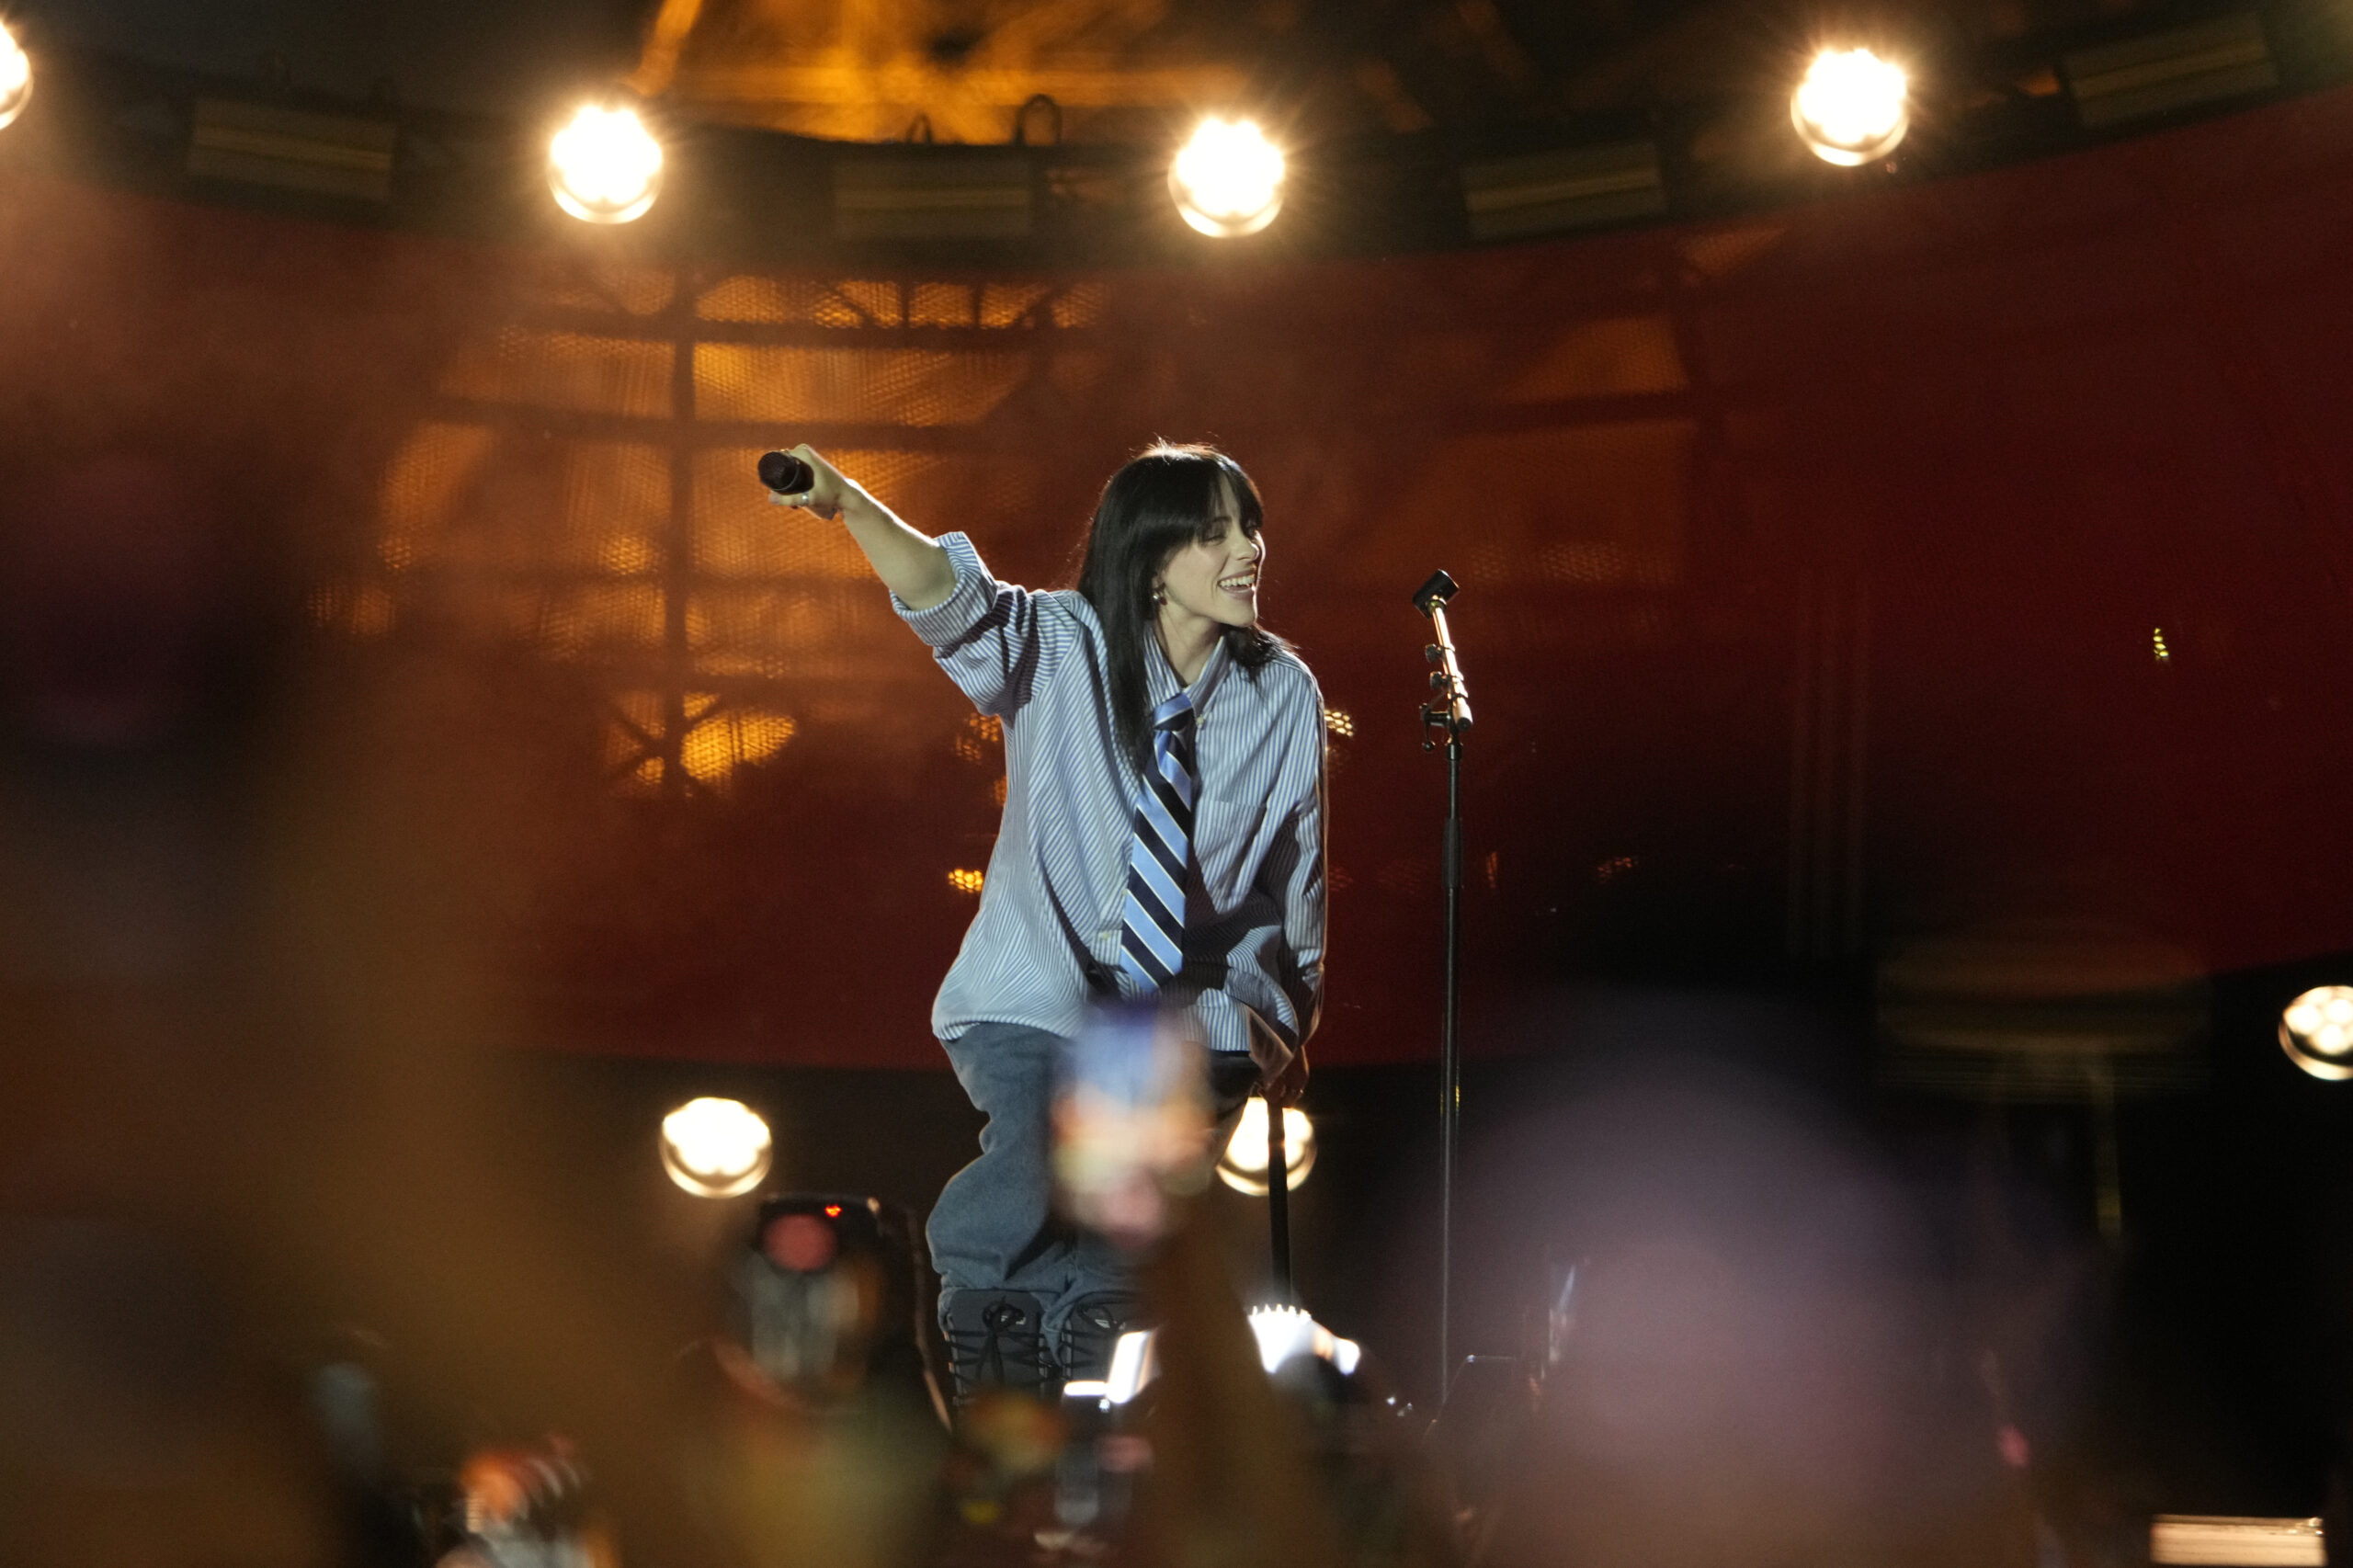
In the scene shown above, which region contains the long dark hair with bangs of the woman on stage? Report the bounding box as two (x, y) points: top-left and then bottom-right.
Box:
(1077, 443), (1285, 772)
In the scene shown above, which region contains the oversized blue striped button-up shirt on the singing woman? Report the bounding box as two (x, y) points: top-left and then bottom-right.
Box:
(894, 534), (1324, 1062)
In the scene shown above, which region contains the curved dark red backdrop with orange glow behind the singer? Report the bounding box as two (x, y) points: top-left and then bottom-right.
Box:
(0, 92), (2353, 1064)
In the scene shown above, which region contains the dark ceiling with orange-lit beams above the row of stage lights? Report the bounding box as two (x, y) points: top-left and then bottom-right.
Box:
(30, 0), (2181, 142)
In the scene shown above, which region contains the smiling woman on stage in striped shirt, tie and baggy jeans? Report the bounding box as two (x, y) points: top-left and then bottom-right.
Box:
(783, 435), (1324, 1401)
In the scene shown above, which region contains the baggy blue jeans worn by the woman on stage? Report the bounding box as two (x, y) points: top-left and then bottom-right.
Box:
(925, 1024), (1256, 1345)
